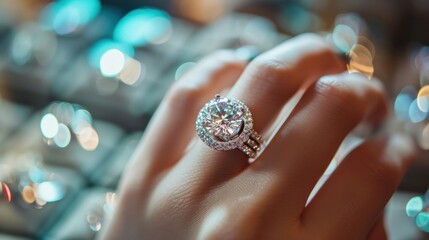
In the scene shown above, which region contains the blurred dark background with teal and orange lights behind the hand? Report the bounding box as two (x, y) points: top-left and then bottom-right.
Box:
(0, 0), (429, 240)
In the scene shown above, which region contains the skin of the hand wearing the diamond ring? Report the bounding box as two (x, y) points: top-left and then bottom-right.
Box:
(100, 34), (414, 239)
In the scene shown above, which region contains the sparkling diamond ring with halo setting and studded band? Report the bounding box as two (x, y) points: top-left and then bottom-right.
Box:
(196, 94), (264, 158)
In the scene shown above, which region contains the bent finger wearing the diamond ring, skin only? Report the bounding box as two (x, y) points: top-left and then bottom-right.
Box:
(175, 34), (345, 189)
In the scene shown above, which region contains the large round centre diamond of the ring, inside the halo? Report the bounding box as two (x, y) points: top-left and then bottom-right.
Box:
(202, 97), (244, 141)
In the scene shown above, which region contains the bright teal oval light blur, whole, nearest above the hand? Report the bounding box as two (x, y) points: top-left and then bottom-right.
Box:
(113, 8), (172, 47)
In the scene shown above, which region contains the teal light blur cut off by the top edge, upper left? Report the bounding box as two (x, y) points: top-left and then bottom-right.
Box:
(41, 0), (101, 35)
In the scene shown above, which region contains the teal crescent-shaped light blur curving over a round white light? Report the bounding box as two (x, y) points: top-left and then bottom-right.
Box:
(88, 39), (134, 68)
